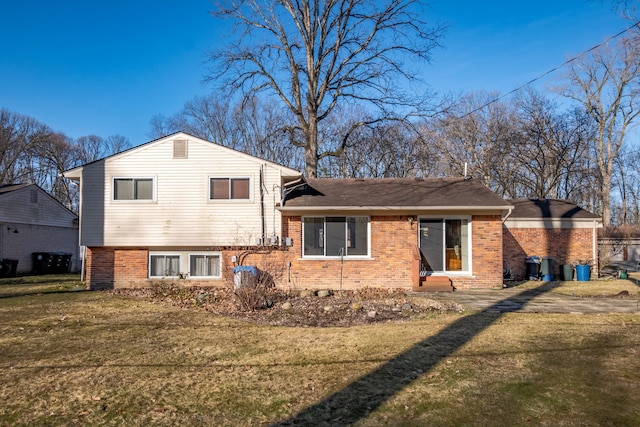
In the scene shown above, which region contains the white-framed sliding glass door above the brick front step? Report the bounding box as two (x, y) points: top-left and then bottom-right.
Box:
(418, 218), (471, 273)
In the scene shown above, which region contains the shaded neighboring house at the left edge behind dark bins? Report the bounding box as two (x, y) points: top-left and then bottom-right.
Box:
(0, 184), (80, 273)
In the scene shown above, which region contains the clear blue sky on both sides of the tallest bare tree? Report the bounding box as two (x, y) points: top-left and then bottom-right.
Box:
(0, 0), (628, 145)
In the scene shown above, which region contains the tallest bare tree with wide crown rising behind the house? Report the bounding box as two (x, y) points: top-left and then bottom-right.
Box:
(209, 0), (442, 177)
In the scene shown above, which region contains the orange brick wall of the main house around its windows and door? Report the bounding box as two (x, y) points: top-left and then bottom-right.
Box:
(87, 215), (502, 290)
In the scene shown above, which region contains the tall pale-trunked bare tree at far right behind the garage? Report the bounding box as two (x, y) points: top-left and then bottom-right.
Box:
(556, 35), (640, 226)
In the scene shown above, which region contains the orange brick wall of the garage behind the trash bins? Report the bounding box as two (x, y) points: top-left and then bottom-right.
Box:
(503, 227), (597, 279)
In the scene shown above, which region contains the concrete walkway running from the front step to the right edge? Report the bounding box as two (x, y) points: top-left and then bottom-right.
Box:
(415, 288), (640, 314)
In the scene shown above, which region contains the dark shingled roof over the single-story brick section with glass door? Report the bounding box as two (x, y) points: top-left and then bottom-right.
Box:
(284, 178), (511, 210)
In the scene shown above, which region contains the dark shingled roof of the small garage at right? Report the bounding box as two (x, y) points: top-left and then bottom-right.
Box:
(509, 199), (600, 220)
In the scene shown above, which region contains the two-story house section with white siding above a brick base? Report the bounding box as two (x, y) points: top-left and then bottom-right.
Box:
(64, 132), (300, 289)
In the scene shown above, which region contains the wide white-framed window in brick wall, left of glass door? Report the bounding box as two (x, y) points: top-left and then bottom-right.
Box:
(302, 216), (369, 257)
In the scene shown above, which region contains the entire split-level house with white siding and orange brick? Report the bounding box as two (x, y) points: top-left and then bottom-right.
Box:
(64, 132), (604, 290)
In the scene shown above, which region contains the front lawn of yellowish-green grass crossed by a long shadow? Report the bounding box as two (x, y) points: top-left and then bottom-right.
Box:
(0, 276), (640, 426)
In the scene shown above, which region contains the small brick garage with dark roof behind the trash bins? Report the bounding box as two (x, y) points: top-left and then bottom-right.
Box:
(503, 199), (602, 278)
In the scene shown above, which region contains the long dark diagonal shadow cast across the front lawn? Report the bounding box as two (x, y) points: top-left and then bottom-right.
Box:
(273, 282), (559, 426)
